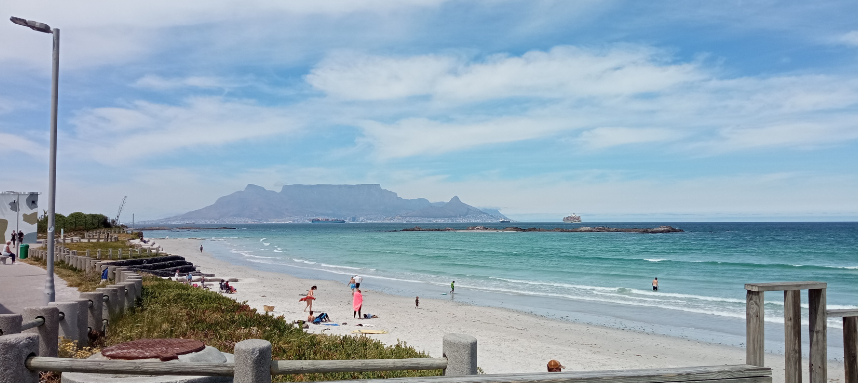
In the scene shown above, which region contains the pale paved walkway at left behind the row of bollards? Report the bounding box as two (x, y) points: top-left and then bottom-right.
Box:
(0, 260), (80, 314)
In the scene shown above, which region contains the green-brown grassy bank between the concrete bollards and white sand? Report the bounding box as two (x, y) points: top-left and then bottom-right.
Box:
(27, 243), (442, 382)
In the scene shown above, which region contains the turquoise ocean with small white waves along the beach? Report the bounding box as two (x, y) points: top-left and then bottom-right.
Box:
(145, 222), (858, 360)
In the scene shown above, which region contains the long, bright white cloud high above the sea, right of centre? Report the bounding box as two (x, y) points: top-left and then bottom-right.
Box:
(307, 46), (708, 102)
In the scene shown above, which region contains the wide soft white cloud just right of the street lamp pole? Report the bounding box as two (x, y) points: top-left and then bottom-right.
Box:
(70, 98), (303, 163)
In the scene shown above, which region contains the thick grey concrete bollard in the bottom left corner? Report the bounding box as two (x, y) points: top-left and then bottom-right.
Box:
(0, 334), (39, 383)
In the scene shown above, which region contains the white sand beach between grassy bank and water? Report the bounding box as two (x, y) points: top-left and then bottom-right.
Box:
(158, 239), (844, 382)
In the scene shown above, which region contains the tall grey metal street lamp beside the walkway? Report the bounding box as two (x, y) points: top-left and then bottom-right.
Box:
(10, 16), (60, 304)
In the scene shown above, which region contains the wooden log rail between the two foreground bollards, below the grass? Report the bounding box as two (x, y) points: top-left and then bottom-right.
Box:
(271, 358), (447, 375)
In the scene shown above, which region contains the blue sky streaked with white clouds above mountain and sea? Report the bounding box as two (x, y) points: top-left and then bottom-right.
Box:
(0, 0), (858, 222)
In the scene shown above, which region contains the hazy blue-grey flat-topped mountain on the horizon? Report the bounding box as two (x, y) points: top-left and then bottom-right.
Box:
(157, 184), (507, 223)
